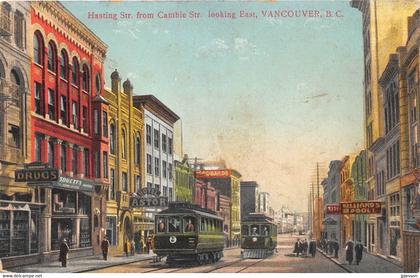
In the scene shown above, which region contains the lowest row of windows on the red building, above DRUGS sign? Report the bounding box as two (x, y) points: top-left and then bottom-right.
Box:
(34, 134), (108, 178)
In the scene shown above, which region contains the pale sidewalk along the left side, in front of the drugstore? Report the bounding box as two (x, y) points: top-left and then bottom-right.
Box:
(6, 253), (154, 273)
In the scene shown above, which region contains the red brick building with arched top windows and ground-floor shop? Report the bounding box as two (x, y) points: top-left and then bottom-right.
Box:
(28, 2), (109, 260)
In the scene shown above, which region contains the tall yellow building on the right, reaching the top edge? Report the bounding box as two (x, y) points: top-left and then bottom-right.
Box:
(351, 0), (418, 255)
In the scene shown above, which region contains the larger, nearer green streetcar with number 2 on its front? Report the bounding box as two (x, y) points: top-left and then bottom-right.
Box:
(153, 202), (224, 264)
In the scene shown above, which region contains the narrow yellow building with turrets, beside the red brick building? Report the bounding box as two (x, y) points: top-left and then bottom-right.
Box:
(105, 70), (146, 254)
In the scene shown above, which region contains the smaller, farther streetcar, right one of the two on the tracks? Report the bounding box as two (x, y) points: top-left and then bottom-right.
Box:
(241, 213), (277, 259)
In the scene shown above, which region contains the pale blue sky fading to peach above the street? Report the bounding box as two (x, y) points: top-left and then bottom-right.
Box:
(64, 1), (363, 211)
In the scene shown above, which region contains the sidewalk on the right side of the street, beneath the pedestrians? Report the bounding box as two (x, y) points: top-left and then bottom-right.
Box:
(318, 248), (403, 273)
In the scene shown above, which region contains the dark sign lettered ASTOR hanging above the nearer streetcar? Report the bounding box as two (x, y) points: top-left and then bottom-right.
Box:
(130, 188), (168, 208)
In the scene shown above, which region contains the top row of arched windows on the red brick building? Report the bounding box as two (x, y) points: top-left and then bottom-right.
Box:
(33, 31), (101, 95)
